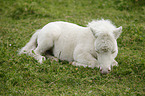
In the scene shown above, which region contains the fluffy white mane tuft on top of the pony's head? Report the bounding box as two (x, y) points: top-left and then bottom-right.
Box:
(87, 19), (116, 33)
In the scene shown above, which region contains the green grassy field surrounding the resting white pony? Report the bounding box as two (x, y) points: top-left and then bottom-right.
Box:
(0, 0), (145, 96)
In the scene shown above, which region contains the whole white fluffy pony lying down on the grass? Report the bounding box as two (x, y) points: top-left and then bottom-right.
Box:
(19, 19), (122, 74)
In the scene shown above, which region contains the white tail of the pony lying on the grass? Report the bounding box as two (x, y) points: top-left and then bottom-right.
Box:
(19, 29), (41, 54)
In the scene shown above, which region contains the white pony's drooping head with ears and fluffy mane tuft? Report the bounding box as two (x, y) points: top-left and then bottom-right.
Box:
(89, 20), (122, 74)
